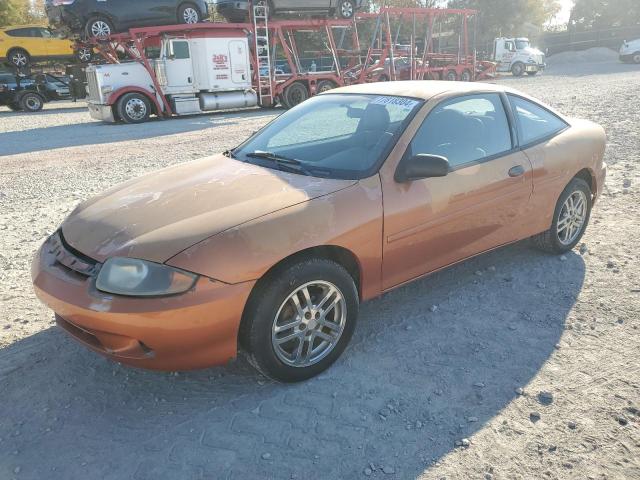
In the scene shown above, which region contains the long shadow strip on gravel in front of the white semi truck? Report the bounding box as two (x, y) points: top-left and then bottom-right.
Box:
(0, 109), (283, 156)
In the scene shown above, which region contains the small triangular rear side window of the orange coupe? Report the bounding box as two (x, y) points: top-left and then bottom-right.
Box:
(509, 95), (568, 145)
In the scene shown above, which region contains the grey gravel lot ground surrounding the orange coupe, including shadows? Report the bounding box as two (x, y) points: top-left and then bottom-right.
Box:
(0, 63), (640, 480)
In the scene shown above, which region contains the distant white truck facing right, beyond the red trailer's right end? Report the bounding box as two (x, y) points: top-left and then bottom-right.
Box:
(493, 37), (547, 77)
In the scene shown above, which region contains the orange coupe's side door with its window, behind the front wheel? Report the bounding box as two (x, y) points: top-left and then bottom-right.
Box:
(380, 92), (533, 289)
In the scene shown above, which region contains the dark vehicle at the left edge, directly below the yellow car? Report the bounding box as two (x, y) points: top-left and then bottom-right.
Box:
(0, 72), (71, 112)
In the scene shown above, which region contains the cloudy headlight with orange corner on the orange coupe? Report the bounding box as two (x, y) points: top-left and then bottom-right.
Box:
(96, 257), (198, 297)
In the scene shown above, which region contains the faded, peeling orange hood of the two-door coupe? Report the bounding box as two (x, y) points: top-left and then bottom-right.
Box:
(61, 155), (356, 262)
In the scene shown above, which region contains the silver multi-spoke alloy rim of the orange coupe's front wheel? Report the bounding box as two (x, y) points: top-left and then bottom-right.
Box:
(271, 280), (347, 367)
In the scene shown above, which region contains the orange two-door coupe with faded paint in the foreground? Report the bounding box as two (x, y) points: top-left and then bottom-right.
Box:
(32, 81), (606, 381)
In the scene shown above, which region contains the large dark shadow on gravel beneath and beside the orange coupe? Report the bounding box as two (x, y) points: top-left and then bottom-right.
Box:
(0, 243), (585, 479)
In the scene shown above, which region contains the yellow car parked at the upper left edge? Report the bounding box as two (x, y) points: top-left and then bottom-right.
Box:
(0, 25), (91, 68)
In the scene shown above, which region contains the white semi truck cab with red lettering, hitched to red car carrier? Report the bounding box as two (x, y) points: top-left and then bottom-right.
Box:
(87, 30), (258, 123)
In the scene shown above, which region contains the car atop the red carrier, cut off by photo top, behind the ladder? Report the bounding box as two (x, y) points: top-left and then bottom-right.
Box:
(213, 0), (364, 22)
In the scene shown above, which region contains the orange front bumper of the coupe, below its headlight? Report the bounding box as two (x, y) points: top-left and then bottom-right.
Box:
(31, 234), (254, 371)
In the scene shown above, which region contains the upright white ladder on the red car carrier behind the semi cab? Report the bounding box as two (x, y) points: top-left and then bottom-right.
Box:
(252, 1), (275, 106)
